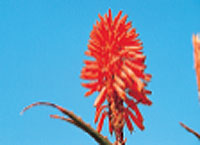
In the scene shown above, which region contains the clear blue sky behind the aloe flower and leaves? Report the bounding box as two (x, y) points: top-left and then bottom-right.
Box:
(0, 0), (200, 145)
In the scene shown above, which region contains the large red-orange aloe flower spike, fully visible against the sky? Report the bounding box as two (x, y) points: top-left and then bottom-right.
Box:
(81, 9), (152, 142)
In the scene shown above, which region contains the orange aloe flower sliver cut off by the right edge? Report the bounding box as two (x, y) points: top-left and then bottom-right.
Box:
(193, 35), (200, 100)
